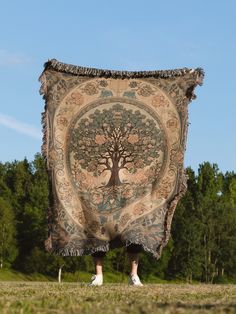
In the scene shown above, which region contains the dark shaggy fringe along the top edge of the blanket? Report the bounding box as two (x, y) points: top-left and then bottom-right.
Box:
(40, 59), (204, 81)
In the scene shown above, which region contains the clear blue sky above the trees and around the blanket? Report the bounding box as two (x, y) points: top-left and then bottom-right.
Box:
(0, 0), (236, 172)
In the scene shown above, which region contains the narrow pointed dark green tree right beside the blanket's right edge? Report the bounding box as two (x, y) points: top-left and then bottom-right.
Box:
(168, 168), (202, 283)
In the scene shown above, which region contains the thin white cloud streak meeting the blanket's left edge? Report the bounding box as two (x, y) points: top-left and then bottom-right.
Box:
(0, 113), (42, 140)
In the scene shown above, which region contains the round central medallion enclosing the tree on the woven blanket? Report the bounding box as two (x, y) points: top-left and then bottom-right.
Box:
(67, 98), (167, 214)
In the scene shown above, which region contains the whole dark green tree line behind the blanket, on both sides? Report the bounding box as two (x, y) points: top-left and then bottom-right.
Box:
(0, 154), (236, 283)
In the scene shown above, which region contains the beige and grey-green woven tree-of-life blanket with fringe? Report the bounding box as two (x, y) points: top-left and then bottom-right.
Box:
(40, 59), (204, 259)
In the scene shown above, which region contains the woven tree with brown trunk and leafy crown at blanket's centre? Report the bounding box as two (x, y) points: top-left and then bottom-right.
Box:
(70, 103), (164, 187)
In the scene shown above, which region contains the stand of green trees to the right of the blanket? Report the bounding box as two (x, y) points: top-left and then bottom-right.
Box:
(168, 162), (236, 283)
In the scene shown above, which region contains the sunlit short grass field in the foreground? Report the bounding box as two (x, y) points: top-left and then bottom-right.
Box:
(0, 281), (236, 314)
